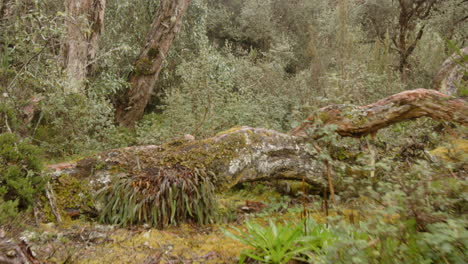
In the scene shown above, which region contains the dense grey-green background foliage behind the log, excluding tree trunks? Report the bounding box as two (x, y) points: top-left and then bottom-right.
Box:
(0, 0), (466, 154)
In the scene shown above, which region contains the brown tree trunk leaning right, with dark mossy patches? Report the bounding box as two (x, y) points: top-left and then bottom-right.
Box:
(116, 0), (191, 127)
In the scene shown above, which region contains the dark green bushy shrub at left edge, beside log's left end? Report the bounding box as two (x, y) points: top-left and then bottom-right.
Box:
(0, 133), (44, 224)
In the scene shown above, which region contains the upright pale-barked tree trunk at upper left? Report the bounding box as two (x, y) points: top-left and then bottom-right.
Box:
(62, 0), (106, 93)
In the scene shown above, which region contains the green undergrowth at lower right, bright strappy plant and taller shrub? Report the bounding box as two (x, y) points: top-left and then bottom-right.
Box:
(226, 167), (468, 264)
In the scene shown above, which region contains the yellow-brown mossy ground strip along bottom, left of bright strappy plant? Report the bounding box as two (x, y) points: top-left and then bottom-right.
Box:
(27, 221), (245, 264)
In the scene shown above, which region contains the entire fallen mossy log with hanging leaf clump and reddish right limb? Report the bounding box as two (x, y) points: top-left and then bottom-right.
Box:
(44, 89), (468, 228)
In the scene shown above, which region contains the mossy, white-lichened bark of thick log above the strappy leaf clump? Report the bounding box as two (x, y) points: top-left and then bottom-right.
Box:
(91, 126), (323, 189)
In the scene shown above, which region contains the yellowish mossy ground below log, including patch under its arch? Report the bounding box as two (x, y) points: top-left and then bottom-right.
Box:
(20, 184), (324, 264)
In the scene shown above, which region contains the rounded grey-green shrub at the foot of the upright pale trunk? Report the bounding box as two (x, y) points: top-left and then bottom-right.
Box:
(33, 91), (126, 157)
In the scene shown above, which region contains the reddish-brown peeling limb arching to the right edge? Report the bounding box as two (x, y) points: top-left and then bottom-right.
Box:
(290, 89), (468, 138)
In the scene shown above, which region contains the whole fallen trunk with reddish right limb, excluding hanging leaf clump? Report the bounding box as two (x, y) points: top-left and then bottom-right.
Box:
(40, 89), (468, 227)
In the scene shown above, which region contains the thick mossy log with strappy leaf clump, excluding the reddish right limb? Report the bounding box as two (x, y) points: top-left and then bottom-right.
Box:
(46, 127), (324, 228)
